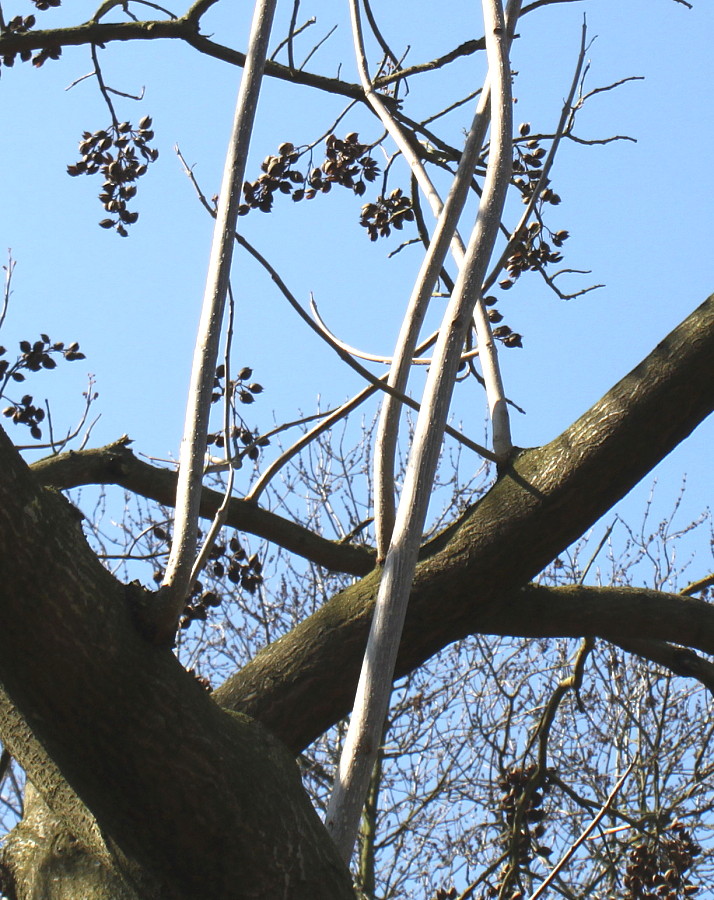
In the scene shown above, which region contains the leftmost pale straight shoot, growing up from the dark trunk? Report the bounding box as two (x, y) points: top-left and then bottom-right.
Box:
(158, 0), (276, 637)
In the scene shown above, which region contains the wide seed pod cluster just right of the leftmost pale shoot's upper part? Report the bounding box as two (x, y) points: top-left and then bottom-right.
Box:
(238, 131), (379, 216)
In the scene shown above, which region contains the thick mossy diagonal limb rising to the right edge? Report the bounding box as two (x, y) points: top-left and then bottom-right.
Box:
(217, 297), (714, 750)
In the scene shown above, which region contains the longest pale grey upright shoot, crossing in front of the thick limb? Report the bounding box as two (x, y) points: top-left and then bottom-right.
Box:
(326, 0), (512, 860)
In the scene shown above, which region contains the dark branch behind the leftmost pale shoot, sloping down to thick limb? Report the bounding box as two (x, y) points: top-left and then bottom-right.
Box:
(31, 437), (376, 575)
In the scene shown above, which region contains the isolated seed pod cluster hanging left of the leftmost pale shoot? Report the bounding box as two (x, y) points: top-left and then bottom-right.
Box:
(67, 116), (159, 237)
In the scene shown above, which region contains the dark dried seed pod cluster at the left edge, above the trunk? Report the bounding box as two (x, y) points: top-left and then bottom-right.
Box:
(0, 334), (84, 440)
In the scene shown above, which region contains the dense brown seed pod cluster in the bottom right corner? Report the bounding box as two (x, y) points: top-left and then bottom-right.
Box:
(623, 824), (702, 900)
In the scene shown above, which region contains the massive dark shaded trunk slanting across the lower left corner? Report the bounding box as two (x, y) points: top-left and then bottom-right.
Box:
(0, 434), (352, 900)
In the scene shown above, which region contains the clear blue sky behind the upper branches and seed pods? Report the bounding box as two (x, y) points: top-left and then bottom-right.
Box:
(0, 0), (714, 577)
